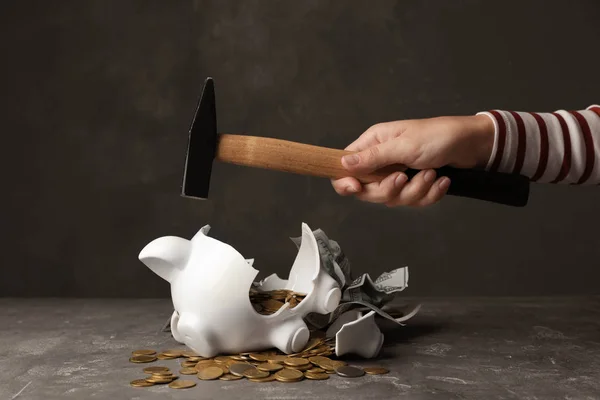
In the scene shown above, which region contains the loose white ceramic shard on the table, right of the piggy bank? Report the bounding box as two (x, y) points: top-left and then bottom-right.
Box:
(335, 311), (383, 358)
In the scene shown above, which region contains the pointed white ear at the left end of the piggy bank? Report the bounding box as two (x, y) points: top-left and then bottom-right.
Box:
(138, 236), (191, 282)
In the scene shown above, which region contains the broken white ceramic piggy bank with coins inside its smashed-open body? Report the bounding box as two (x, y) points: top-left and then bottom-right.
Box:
(139, 224), (341, 357)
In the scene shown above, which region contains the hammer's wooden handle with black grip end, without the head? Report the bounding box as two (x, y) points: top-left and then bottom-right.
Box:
(216, 134), (529, 207)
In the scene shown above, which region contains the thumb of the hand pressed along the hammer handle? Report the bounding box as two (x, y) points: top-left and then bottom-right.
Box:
(342, 140), (407, 174)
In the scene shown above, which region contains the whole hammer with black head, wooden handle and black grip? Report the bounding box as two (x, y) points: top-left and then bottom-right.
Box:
(181, 78), (529, 207)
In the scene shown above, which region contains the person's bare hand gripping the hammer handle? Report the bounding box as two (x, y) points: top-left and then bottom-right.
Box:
(332, 115), (494, 207)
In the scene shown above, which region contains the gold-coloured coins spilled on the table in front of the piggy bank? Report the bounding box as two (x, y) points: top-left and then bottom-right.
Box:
(129, 333), (389, 389)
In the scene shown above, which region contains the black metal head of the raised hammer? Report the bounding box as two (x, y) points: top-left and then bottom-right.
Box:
(181, 78), (217, 199)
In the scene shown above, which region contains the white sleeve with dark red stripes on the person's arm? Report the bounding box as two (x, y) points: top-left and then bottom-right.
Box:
(478, 105), (600, 185)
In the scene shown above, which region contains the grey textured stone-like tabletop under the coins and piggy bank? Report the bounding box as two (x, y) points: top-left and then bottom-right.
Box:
(0, 297), (600, 400)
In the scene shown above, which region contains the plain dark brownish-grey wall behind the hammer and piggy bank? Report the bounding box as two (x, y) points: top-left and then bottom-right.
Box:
(0, 0), (600, 297)
